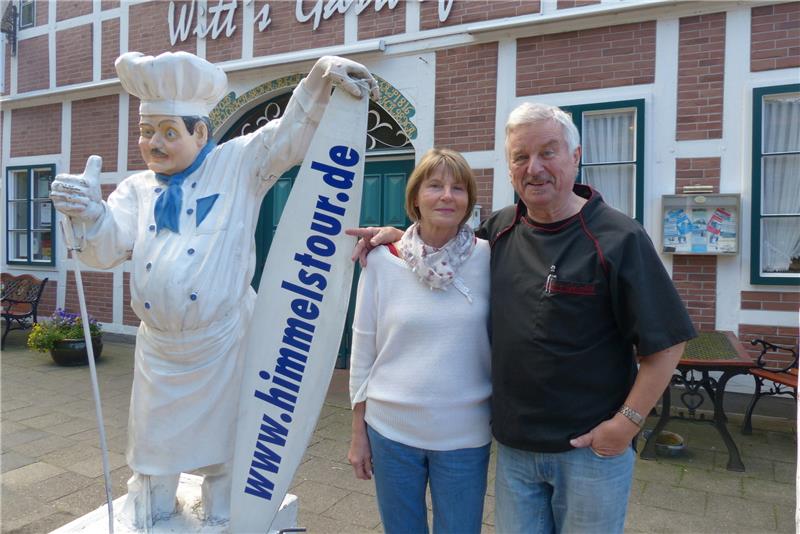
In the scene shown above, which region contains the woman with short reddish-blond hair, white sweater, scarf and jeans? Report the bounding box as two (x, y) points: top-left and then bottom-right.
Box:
(348, 149), (491, 534)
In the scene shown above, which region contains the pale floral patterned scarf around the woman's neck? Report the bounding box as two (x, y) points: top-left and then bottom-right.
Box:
(398, 223), (476, 302)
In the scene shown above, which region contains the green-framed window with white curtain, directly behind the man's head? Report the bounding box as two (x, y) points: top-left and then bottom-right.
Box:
(562, 100), (644, 222)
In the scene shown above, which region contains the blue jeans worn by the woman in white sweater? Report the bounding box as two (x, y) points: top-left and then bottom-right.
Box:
(367, 425), (490, 534)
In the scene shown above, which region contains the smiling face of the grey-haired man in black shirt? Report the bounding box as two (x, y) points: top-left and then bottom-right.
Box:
(506, 120), (581, 222)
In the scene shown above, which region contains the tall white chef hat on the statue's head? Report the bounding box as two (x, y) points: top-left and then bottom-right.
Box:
(114, 52), (228, 117)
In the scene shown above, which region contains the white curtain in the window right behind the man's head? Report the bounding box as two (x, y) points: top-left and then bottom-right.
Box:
(582, 110), (636, 217)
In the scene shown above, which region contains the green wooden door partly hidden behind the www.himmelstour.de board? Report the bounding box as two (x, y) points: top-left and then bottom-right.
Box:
(251, 159), (414, 369)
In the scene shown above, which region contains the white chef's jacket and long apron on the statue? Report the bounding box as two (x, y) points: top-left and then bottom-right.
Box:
(72, 80), (330, 475)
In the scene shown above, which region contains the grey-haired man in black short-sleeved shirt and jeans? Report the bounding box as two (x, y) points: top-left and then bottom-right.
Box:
(350, 103), (696, 533)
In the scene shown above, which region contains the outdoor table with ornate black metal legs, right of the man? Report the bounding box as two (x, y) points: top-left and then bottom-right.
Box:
(640, 331), (753, 471)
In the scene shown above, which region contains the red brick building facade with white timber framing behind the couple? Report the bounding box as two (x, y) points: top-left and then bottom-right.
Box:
(0, 0), (800, 376)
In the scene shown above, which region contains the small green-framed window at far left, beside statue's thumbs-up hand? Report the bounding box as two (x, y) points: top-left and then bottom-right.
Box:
(6, 165), (55, 265)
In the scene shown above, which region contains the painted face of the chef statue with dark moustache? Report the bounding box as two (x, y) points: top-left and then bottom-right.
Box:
(139, 115), (207, 175)
